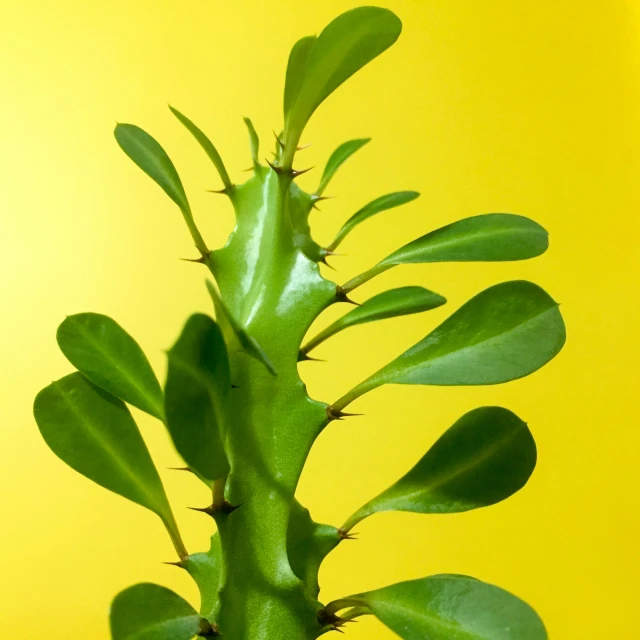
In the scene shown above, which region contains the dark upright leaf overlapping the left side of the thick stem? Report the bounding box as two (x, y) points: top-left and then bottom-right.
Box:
(165, 313), (231, 480)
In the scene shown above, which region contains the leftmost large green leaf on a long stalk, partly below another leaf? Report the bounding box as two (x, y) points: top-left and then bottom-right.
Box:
(33, 373), (187, 557)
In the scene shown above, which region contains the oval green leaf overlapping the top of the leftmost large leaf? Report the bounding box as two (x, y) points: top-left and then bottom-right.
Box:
(56, 313), (164, 420)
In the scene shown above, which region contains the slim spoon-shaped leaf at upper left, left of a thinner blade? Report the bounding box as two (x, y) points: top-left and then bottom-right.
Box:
(114, 124), (209, 255)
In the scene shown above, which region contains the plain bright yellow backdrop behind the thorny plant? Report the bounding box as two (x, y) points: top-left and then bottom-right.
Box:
(0, 0), (640, 640)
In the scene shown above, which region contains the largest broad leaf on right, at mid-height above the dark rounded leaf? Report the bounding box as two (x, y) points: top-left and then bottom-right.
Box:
(333, 280), (565, 410)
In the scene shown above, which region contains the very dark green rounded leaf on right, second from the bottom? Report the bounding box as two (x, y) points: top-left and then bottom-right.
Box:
(342, 407), (536, 531)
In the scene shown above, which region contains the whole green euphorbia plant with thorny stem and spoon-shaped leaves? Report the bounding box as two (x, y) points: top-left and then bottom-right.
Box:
(35, 7), (564, 640)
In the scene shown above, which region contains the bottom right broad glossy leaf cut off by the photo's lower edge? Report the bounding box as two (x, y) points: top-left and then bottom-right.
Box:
(350, 575), (547, 640)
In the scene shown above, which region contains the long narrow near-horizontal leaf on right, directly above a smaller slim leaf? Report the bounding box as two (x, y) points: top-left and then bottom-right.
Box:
(341, 213), (549, 292)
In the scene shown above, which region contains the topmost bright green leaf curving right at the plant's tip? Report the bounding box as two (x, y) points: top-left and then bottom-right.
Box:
(285, 7), (402, 158)
